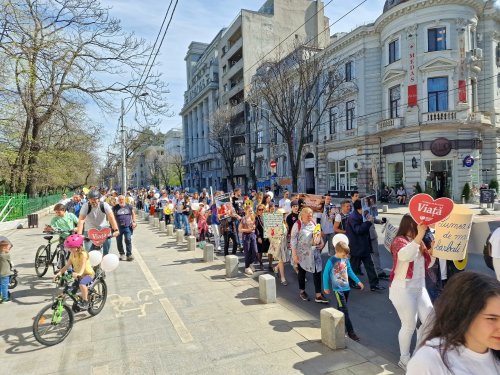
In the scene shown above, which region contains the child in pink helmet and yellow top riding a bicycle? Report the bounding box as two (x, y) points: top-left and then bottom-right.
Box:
(54, 234), (95, 309)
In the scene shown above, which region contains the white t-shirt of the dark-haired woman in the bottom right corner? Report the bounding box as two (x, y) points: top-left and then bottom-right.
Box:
(406, 338), (500, 375)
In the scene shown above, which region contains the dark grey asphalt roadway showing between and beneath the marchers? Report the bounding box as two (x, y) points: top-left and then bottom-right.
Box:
(229, 215), (499, 363)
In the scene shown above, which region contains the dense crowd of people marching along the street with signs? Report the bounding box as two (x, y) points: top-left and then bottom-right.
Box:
(0, 188), (500, 375)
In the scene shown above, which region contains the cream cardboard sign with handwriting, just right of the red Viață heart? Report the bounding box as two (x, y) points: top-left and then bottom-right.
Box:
(432, 204), (473, 260)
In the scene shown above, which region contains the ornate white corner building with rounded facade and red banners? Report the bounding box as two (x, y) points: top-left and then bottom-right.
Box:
(254, 0), (500, 200)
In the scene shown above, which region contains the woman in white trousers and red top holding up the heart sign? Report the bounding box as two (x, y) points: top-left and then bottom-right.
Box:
(389, 215), (434, 370)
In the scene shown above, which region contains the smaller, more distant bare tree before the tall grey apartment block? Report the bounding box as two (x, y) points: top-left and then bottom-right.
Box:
(209, 105), (245, 189)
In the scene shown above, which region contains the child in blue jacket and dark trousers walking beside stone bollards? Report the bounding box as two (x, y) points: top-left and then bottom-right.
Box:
(323, 241), (364, 341)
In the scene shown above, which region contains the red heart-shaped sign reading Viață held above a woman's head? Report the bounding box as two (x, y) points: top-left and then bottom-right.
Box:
(409, 194), (453, 225)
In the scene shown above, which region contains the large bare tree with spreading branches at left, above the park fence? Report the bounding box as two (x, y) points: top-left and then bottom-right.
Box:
(0, 0), (168, 195)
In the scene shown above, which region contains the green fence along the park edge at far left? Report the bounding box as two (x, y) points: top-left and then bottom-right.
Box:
(0, 194), (67, 222)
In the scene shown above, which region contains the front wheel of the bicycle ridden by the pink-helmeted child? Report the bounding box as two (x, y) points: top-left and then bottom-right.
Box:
(33, 303), (74, 346)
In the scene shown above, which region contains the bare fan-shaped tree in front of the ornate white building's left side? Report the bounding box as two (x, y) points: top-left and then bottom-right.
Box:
(251, 44), (353, 191)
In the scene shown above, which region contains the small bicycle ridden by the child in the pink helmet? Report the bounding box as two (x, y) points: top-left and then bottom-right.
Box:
(33, 268), (108, 346)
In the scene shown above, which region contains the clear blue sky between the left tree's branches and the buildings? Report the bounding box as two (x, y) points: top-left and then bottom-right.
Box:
(99, 0), (385, 143)
